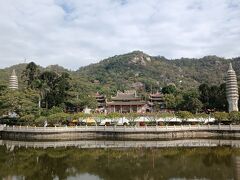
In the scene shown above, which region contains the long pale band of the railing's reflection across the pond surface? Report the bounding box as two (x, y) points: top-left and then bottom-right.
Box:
(0, 139), (240, 151)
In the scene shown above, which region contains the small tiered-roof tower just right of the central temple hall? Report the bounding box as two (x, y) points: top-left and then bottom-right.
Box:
(148, 92), (166, 112)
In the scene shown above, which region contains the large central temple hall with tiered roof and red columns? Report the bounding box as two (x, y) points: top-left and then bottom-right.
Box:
(107, 91), (146, 113)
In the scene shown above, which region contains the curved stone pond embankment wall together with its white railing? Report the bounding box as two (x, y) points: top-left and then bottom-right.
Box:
(0, 125), (240, 140)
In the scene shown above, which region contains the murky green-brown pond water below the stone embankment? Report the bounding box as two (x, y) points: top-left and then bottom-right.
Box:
(0, 140), (240, 180)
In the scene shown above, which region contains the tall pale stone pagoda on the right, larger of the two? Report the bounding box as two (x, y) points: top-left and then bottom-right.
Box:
(226, 63), (239, 112)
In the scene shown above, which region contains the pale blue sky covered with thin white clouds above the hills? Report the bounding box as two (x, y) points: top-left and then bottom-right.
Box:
(0, 0), (240, 70)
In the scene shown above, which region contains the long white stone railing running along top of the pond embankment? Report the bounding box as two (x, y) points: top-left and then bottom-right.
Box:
(0, 125), (240, 133)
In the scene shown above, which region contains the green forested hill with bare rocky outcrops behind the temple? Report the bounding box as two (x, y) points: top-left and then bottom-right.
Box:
(0, 51), (240, 92)
